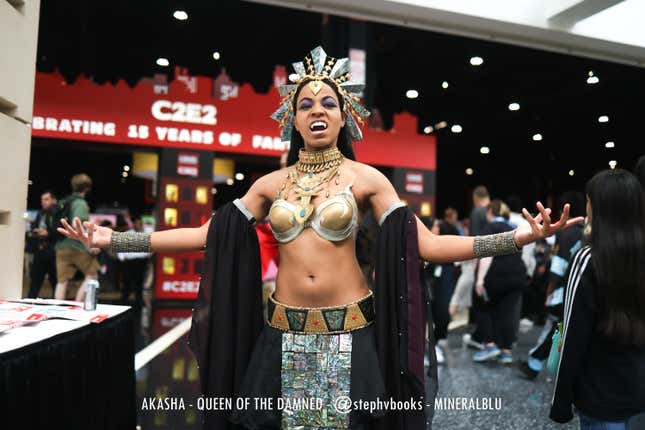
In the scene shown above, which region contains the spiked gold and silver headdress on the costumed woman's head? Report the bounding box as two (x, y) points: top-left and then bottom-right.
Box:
(271, 46), (370, 141)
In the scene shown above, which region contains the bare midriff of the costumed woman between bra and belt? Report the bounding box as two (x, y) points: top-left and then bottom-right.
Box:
(274, 228), (369, 307)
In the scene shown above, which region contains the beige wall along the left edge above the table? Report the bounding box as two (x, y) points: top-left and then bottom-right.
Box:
(0, 0), (40, 299)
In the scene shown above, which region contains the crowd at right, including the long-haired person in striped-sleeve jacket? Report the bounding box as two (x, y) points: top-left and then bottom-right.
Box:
(421, 156), (645, 430)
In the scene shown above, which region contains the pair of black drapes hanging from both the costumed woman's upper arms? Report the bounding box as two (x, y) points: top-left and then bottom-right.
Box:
(189, 203), (437, 430)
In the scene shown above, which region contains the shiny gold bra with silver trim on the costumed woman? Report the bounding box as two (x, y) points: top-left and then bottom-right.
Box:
(269, 184), (358, 243)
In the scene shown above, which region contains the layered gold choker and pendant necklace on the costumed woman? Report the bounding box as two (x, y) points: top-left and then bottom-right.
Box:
(276, 148), (344, 224)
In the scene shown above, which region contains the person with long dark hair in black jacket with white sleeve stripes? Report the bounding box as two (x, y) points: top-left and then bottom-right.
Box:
(549, 169), (645, 430)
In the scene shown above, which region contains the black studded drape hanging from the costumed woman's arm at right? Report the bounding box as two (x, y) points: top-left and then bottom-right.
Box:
(374, 207), (437, 430)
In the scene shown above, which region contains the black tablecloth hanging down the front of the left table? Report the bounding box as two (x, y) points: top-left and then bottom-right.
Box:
(0, 310), (136, 430)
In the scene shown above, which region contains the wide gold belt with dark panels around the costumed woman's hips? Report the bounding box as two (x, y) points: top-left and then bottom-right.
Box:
(267, 291), (374, 334)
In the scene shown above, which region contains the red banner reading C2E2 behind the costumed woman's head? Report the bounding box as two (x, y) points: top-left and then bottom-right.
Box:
(32, 69), (436, 170)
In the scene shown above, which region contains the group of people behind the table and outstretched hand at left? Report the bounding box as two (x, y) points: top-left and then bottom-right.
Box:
(25, 173), (150, 309)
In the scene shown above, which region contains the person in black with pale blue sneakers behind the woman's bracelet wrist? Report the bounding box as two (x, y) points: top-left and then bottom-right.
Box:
(473, 199), (526, 364)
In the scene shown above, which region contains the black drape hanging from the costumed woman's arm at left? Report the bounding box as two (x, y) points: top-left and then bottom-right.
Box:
(190, 203), (263, 430)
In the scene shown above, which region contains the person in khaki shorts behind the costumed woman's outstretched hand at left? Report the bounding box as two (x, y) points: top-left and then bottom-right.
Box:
(54, 173), (100, 301)
